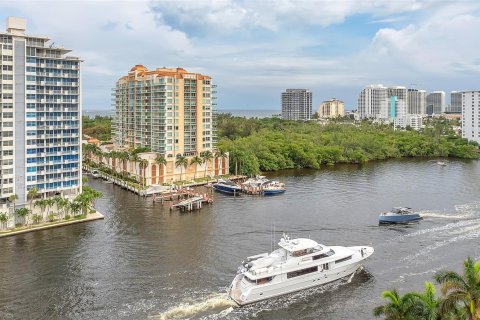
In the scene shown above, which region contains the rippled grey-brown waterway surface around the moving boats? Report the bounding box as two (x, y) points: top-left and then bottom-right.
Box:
(0, 160), (480, 319)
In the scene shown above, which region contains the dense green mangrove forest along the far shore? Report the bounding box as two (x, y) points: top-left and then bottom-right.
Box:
(217, 114), (479, 175)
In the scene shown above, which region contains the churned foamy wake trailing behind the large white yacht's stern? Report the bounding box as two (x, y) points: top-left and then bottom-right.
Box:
(151, 293), (237, 320)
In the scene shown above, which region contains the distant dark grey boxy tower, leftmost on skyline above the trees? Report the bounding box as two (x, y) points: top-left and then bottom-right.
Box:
(282, 89), (312, 120)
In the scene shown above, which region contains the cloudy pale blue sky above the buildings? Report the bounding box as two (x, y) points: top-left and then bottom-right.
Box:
(0, 0), (480, 111)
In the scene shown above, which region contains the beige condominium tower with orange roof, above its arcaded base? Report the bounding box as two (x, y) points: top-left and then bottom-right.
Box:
(113, 65), (215, 156)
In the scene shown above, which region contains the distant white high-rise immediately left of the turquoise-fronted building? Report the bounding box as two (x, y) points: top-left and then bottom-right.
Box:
(357, 84), (389, 120)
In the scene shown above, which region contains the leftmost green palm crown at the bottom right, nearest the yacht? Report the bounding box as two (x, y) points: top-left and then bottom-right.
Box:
(373, 289), (418, 320)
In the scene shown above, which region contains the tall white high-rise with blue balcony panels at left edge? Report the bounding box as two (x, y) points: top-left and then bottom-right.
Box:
(0, 17), (81, 204)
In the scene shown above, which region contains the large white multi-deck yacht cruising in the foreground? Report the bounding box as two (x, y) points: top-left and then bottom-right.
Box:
(228, 235), (374, 306)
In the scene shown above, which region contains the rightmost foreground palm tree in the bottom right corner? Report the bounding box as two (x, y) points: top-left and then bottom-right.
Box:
(434, 257), (480, 320)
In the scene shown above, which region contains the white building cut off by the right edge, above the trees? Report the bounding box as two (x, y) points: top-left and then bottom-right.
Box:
(462, 90), (480, 143)
